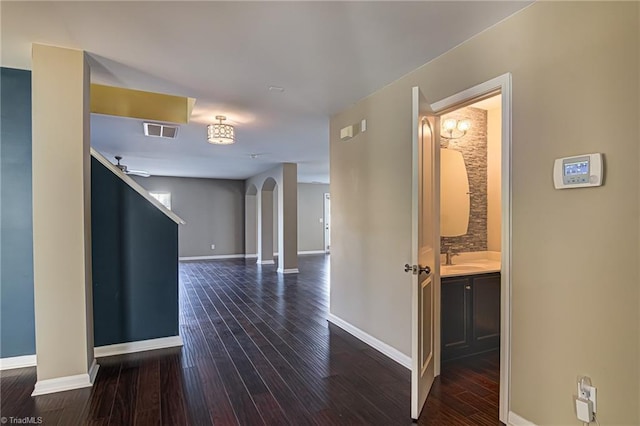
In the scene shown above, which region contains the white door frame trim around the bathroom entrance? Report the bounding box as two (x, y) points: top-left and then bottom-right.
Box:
(431, 73), (512, 424)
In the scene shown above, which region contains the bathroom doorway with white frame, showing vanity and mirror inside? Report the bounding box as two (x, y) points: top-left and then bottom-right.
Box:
(430, 74), (511, 424)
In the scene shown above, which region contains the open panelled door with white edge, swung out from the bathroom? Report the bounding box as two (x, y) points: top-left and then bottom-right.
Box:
(405, 87), (440, 420)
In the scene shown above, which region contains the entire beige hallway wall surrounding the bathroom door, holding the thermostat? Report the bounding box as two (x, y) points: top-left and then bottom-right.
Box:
(330, 2), (640, 425)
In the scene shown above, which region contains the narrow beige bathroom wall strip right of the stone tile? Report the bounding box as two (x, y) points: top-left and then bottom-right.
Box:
(487, 108), (502, 251)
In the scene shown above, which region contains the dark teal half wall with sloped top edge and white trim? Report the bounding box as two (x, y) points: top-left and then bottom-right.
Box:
(91, 158), (178, 346)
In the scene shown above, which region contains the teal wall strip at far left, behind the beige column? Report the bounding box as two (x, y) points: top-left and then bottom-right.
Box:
(0, 68), (36, 358)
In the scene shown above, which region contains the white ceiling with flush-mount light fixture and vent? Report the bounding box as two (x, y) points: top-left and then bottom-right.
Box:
(0, 1), (530, 183)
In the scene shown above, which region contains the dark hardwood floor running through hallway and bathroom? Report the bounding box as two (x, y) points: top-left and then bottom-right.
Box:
(0, 255), (499, 426)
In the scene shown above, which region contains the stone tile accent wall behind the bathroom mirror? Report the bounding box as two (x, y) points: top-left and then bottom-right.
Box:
(440, 107), (487, 253)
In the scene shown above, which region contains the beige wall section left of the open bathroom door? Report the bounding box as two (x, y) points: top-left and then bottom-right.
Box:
(329, 84), (411, 355)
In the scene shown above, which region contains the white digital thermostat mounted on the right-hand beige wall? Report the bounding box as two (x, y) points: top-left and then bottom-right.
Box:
(553, 153), (603, 189)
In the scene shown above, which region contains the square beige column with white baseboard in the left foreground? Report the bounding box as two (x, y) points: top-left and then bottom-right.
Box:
(32, 44), (98, 395)
